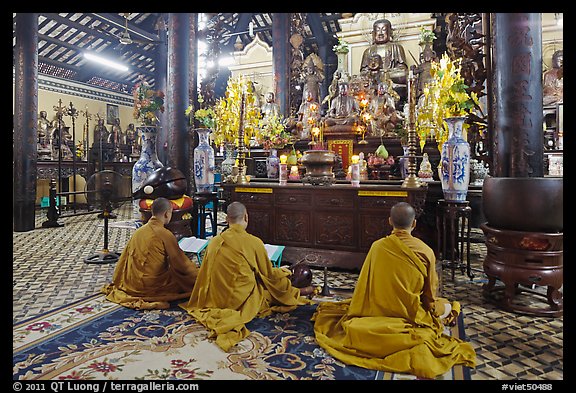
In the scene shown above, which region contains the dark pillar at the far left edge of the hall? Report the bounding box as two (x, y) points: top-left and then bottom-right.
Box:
(12, 13), (38, 232)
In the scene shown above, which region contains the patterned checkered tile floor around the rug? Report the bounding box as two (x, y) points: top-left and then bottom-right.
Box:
(13, 203), (564, 380)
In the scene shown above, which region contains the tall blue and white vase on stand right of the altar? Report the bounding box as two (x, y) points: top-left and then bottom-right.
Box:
(438, 116), (470, 202)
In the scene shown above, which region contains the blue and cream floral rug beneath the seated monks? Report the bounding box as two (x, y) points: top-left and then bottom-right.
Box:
(13, 294), (470, 380)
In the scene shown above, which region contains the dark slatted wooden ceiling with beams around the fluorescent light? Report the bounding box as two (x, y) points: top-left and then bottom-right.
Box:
(12, 13), (342, 93)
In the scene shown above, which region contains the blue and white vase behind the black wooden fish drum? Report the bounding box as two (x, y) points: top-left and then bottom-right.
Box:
(132, 126), (164, 211)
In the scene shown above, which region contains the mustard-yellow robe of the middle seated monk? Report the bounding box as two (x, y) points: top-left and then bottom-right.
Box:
(180, 224), (310, 351)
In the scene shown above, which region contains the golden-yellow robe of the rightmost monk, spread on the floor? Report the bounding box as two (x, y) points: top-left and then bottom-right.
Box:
(313, 230), (476, 378)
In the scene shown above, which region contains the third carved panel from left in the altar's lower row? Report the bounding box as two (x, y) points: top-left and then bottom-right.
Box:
(314, 211), (357, 247)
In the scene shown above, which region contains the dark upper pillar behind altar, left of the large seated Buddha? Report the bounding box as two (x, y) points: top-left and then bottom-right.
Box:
(272, 12), (291, 117)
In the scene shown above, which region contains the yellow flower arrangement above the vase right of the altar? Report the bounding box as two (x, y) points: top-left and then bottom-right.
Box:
(416, 53), (480, 151)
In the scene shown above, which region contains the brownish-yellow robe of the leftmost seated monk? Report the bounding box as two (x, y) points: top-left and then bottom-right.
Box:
(102, 216), (198, 310)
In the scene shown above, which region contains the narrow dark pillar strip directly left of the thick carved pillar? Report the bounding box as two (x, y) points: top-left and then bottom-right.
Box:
(154, 14), (169, 165)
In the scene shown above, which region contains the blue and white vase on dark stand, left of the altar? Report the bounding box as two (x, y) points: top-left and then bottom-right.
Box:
(194, 128), (216, 193)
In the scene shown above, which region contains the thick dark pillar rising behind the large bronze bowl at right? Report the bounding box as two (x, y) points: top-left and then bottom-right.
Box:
(489, 13), (544, 177)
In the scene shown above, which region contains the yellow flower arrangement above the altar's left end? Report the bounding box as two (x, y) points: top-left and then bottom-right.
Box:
(211, 75), (261, 146)
